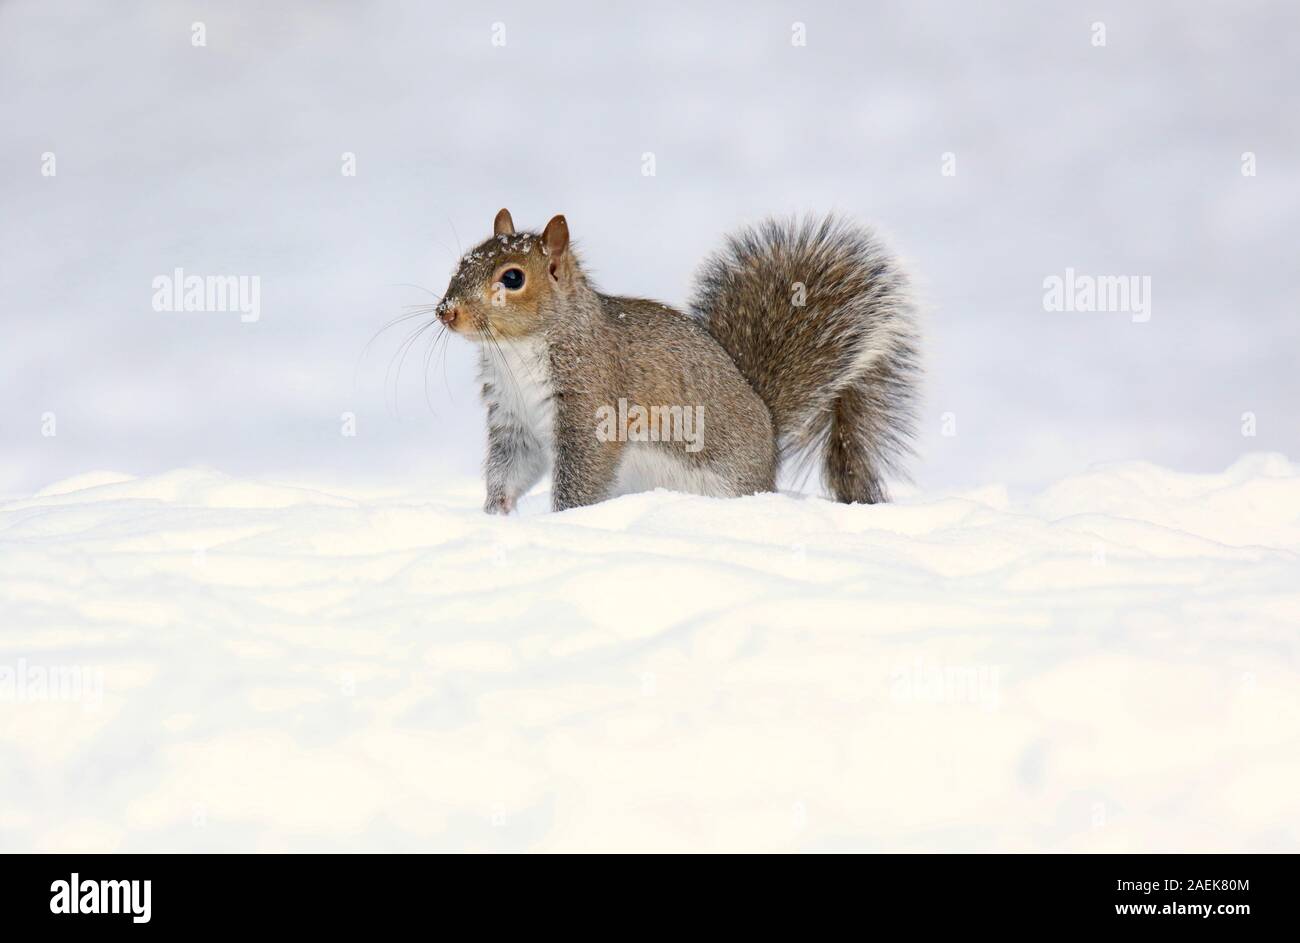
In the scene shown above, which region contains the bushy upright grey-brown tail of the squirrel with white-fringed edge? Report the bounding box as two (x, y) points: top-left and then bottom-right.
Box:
(692, 217), (920, 503)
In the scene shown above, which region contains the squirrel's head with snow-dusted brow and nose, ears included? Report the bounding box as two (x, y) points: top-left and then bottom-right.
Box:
(437, 209), (582, 339)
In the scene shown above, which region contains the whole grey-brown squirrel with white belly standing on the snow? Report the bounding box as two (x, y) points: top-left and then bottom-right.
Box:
(434, 209), (920, 514)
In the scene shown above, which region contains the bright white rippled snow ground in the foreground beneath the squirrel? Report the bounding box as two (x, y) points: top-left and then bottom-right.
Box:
(0, 454), (1300, 852)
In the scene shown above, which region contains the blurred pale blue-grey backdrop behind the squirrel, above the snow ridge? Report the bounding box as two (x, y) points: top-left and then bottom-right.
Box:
(0, 0), (1300, 494)
